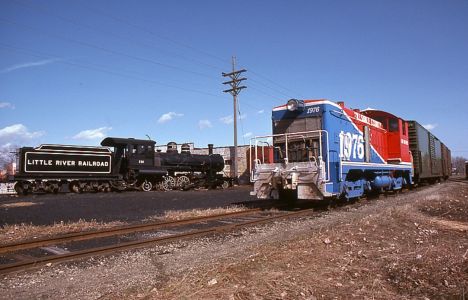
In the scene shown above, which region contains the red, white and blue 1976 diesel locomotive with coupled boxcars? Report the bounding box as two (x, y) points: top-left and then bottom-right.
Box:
(250, 99), (451, 200)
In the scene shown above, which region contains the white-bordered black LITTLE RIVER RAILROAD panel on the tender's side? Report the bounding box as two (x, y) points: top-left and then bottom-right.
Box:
(24, 152), (111, 174)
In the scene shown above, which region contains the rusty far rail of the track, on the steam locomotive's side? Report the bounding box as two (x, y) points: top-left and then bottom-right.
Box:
(0, 208), (261, 254)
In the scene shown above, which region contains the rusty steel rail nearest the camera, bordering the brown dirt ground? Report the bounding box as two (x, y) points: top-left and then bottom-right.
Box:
(0, 209), (314, 274)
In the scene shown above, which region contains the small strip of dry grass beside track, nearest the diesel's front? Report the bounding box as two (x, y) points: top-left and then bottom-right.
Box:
(144, 205), (248, 221)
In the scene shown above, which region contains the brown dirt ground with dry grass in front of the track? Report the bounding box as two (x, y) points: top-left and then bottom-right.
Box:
(0, 182), (468, 299)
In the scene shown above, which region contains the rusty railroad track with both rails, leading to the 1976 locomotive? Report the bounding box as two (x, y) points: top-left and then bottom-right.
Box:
(0, 209), (314, 274)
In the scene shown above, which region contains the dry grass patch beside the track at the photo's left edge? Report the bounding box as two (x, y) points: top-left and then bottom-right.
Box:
(0, 219), (125, 244)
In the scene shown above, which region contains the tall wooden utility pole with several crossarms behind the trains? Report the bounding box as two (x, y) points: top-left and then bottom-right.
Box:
(222, 56), (247, 181)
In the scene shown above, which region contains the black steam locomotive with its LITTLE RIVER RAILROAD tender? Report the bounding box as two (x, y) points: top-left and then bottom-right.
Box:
(11, 137), (230, 194)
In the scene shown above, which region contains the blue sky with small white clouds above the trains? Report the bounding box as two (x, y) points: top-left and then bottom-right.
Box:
(0, 0), (468, 157)
